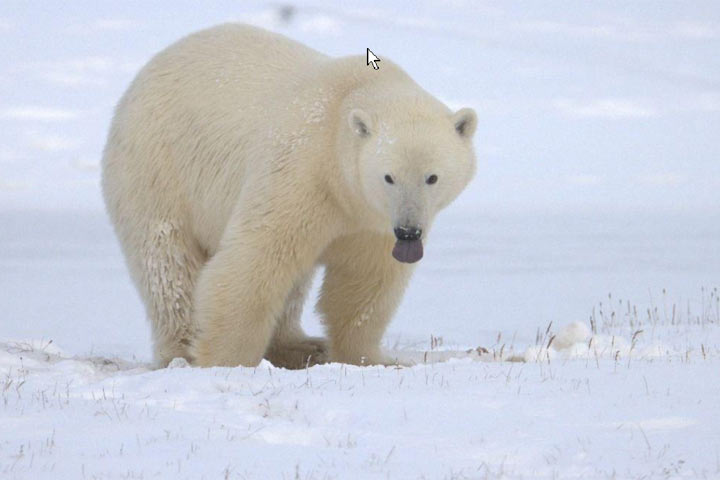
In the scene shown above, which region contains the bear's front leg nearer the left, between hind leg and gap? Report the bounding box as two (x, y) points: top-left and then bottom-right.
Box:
(192, 205), (336, 367)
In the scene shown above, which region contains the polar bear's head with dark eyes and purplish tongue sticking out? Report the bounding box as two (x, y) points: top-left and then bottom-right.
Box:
(344, 98), (477, 263)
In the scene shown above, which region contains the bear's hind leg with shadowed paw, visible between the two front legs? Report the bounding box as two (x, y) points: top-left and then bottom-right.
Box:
(265, 276), (327, 369)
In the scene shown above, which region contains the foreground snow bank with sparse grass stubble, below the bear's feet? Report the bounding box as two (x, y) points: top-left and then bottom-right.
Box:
(0, 332), (720, 478)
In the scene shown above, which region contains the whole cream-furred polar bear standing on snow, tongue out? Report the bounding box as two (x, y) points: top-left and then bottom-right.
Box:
(102, 24), (477, 368)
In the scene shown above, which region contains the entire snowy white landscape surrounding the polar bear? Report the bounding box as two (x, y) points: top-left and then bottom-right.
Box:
(0, 0), (720, 479)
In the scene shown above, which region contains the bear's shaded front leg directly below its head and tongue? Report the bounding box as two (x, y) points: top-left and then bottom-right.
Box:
(318, 232), (413, 365)
